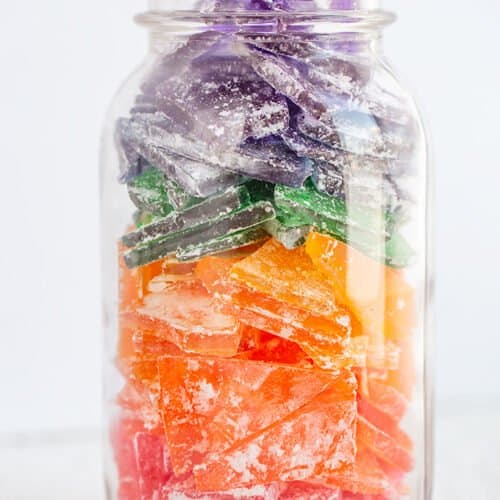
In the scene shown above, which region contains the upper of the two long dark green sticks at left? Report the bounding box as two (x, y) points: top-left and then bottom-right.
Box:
(122, 186), (254, 247)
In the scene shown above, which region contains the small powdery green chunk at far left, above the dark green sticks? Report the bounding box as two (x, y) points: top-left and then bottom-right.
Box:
(128, 168), (174, 215)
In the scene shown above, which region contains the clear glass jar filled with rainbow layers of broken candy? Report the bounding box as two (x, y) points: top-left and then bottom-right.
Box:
(102, 0), (432, 500)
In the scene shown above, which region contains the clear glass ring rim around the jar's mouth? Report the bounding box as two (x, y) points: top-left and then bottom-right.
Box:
(134, 9), (396, 33)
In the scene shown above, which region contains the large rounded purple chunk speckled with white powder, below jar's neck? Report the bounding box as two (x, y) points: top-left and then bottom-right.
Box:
(156, 57), (289, 149)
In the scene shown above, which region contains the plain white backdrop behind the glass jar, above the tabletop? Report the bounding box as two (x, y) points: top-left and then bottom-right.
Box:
(0, 0), (500, 434)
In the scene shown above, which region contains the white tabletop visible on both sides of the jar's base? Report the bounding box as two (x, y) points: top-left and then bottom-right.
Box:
(0, 405), (500, 500)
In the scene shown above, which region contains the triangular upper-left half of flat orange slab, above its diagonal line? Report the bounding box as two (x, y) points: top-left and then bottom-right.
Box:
(158, 356), (344, 474)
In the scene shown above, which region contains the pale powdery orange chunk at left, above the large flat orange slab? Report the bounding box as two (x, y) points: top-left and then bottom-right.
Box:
(124, 282), (240, 356)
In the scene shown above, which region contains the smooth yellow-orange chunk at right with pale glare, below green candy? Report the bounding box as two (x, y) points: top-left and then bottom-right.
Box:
(306, 232), (415, 345)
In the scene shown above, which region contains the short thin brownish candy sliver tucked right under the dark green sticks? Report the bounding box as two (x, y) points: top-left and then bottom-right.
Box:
(175, 227), (269, 262)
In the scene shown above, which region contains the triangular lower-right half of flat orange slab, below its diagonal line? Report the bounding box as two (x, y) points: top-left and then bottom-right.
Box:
(195, 371), (356, 491)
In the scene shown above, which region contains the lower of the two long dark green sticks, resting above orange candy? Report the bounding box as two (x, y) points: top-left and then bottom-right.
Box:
(124, 201), (276, 268)
